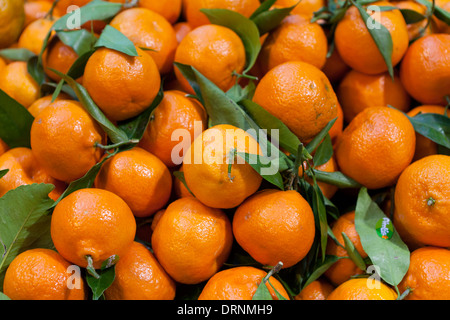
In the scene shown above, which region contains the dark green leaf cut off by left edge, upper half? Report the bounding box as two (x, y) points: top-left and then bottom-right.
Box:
(0, 89), (34, 148)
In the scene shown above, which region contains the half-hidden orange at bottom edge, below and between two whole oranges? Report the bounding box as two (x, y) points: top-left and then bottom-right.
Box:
(105, 241), (176, 300)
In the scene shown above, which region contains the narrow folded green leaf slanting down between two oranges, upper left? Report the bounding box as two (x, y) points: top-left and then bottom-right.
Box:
(50, 69), (130, 143)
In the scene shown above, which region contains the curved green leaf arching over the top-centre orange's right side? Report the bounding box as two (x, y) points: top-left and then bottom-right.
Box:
(200, 9), (261, 74)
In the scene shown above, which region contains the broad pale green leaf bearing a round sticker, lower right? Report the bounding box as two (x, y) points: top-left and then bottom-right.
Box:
(355, 187), (410, 286)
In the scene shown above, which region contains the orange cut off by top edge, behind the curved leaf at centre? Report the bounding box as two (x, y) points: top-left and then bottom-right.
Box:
(183, 0), (260, 28)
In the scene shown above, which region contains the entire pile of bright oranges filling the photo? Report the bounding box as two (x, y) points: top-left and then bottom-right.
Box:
(0, 0), (450, 300)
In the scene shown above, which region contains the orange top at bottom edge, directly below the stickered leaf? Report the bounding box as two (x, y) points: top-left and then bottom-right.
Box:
(327, 278), (397, 300)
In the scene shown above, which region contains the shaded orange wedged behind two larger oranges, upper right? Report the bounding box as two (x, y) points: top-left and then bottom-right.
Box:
(336, 70), (411, 123)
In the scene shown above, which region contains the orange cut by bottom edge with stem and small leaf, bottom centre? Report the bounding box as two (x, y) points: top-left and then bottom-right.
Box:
(198, 266), (290, 300)
